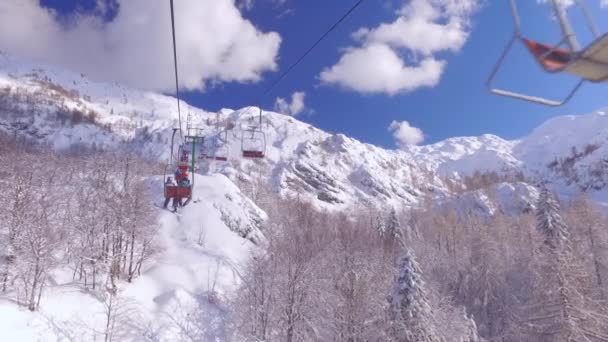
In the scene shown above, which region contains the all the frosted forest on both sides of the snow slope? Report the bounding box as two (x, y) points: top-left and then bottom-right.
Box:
(0, 130), (608, 342)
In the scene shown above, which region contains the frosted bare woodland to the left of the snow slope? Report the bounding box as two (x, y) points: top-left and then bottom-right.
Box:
(0, 136), (157, 341)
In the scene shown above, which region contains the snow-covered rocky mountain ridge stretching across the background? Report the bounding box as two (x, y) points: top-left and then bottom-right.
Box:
(0, 54), (608, 209)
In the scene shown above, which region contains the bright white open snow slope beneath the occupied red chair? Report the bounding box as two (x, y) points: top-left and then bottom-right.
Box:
(0, 174), (266, 342)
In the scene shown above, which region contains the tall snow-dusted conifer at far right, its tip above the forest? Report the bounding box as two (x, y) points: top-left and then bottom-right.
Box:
(525, 188), (608, 342)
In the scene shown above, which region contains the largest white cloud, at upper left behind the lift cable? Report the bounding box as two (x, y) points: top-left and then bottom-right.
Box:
(0, 0), (281, 91)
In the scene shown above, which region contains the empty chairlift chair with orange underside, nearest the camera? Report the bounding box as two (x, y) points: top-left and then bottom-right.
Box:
(486, 0), (608, 106)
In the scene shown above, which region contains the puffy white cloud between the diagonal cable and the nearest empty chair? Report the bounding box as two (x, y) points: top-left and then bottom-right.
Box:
(320, 0), (481, 95)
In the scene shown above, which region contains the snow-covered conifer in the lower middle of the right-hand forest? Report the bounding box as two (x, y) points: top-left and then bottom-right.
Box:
(388, 251), (440, 342)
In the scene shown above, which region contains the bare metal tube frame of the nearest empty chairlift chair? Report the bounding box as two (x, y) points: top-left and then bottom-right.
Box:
(486, 0), (608, 107)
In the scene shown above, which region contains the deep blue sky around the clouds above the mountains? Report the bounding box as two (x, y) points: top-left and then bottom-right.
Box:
(17, 0), (608, 148)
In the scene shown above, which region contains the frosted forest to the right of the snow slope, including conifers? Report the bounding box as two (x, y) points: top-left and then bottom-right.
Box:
(233, 174), (608, 342)
